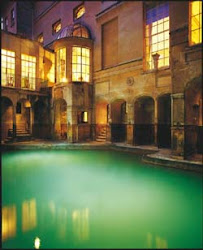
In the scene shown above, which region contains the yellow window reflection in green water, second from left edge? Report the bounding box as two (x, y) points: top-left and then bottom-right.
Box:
(22, 199), (37, 232)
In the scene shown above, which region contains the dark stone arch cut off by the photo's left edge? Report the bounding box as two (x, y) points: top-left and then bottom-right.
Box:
(1, 96), (14, 141)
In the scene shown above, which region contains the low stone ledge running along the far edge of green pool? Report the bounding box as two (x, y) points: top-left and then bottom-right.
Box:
(1, 143), (203, 173)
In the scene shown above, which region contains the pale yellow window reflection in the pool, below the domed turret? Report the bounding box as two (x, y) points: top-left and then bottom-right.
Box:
(72, 208), (89, 241)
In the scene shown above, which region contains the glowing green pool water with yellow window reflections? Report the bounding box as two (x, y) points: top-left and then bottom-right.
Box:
(2, 150), (202, 249)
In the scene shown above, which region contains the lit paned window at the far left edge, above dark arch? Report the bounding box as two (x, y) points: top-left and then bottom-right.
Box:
(1, 49), (15, 87)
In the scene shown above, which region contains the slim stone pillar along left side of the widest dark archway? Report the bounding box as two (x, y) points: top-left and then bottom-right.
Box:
(126, 103), (134, 145)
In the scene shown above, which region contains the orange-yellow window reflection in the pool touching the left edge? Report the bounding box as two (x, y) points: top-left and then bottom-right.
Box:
(2, 205), (17, 241)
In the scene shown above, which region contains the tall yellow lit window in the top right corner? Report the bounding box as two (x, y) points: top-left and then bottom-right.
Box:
(189, 1), (202, 45)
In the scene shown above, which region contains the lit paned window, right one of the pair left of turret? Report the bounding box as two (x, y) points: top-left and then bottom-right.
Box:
(21, 54), (36, 90)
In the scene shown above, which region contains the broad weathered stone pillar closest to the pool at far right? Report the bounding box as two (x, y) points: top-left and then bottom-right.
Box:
(171, 93), (185, 159)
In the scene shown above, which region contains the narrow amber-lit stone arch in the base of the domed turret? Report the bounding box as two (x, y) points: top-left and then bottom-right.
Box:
(54, 98), (68, 140)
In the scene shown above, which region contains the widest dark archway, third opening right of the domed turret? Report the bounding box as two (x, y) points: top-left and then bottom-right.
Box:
(133, 96), (155, 145)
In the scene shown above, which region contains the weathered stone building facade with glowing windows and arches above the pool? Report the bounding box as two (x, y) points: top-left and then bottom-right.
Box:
(2, 1), (202, 158)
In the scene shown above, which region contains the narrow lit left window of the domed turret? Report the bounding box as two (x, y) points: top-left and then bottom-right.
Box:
(56, 48), (67, 83)
